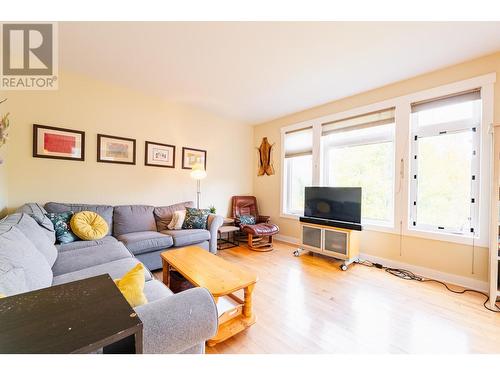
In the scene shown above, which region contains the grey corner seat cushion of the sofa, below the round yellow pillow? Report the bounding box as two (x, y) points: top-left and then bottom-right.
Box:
(52, 241), (132, 276)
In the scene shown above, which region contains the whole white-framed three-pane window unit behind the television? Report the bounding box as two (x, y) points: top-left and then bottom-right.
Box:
(280, 73), (496, 246)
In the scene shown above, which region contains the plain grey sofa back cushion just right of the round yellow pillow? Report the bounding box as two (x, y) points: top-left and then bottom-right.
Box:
(113, 205), (156, 237)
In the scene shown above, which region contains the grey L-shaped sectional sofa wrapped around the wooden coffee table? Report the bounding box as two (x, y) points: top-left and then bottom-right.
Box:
(0, 203), (223, 353)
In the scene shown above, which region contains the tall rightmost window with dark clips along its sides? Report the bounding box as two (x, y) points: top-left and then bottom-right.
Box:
(409, 90), (481, 236)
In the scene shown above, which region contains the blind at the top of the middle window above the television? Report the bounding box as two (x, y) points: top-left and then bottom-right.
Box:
(321, 108), (395, 136)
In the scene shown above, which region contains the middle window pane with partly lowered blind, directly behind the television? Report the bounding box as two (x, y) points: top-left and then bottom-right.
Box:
(321, 108), (394, 226)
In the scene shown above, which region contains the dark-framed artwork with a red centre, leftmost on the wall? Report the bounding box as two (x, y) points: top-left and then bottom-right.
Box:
(33, 124), (85, 161)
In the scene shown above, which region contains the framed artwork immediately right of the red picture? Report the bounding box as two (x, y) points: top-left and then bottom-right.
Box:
(97, 134), (135, 164)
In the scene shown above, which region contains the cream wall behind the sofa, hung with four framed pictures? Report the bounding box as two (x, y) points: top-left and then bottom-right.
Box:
(0, 72), (253, 215)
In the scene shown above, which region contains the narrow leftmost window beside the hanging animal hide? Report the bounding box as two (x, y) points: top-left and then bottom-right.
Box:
(284, 128), (312, 215)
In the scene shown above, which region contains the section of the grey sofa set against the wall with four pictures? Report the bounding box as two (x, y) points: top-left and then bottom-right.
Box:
(45, 201), (224, 271)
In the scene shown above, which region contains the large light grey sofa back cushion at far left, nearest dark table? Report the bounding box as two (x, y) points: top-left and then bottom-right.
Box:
(0, 225), (52, 295)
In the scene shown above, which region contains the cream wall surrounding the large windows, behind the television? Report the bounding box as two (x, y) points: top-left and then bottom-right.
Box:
(253, 53), (500, 281)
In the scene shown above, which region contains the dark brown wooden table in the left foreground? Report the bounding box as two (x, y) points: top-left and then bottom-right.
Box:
(0, 274), (142, 353)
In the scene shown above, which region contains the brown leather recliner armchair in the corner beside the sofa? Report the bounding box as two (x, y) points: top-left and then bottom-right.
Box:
(231, 195), (279, 251)
